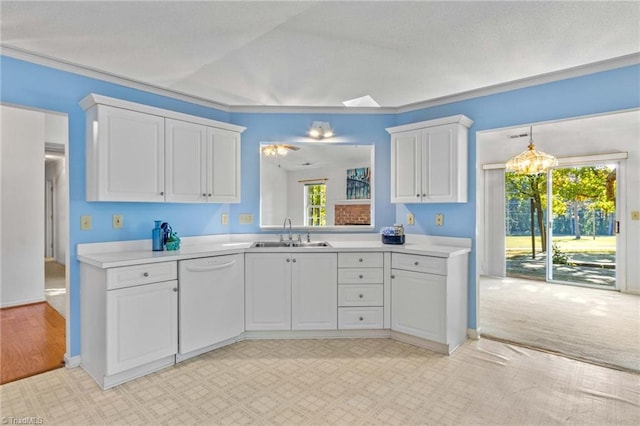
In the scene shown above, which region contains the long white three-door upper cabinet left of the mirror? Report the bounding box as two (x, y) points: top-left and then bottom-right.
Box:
(80, 94), (245, 203)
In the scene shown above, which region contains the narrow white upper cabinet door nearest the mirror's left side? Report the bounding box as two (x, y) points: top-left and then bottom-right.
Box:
(207, 128), (240, 203)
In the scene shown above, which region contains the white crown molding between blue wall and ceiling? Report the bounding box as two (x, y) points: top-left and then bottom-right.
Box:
(0, 43), (640, 114)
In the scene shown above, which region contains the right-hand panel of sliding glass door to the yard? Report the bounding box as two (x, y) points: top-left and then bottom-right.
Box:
(546, 164), (618, 289)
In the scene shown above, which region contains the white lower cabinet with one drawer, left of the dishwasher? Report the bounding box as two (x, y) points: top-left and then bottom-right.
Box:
(80, 261), (178, 389)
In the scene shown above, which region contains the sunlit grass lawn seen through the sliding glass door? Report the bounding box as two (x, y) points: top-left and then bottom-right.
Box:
(506, 235), (616, 255)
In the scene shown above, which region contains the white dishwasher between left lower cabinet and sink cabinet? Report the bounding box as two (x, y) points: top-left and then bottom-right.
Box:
(178, 254), (244, 361)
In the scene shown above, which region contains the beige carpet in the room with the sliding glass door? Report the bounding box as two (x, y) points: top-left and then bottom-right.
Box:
(480, 277), (640, 372)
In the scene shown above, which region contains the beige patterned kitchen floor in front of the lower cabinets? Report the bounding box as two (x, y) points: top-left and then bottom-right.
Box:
(0, 339), (640, 426)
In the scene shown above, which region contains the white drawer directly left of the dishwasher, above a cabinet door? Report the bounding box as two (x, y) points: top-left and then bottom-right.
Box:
(107, 262), (178, 290)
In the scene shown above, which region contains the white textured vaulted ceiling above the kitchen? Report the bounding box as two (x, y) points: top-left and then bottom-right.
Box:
(0, 0), (640, 107)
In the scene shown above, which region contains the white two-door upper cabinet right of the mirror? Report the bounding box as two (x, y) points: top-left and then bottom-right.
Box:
(387, 115), (473, 203)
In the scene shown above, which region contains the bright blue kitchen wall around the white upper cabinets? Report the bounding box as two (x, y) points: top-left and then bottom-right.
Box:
(0, 56), (640, 356)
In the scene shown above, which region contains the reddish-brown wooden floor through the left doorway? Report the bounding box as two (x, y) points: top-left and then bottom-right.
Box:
(0, 302), (65, 384)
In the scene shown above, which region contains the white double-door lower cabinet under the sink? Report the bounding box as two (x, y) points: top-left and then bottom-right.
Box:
(245, 253), (338, 331)
